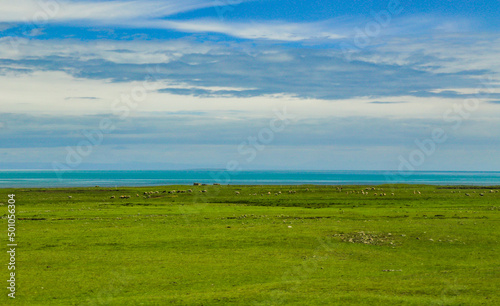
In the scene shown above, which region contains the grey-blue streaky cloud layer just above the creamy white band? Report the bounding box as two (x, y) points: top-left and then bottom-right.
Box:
(0, 33), (500, 102)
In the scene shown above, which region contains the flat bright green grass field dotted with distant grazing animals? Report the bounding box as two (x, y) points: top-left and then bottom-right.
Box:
(0, 185), (500, 305)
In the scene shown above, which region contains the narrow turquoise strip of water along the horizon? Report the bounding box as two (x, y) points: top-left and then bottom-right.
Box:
(0, 170), (500, 188)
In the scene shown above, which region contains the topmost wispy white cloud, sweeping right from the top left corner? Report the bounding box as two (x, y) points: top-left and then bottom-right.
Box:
(0, 0), (484, 44)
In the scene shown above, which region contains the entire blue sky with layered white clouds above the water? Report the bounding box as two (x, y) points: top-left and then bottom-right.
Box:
(0, 0), (500, 171)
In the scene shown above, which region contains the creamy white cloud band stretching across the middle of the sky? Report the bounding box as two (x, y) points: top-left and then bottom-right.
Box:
(0, 71), (500, 120)
